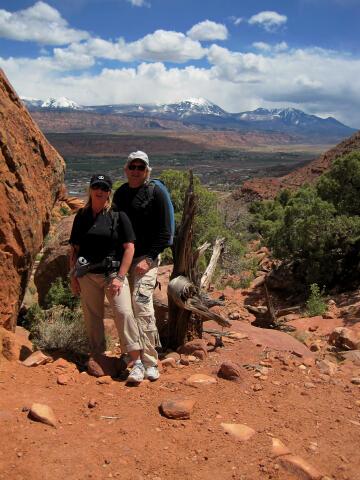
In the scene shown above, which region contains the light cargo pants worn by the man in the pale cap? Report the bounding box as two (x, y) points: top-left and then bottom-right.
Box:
(128, 259), (161, 368)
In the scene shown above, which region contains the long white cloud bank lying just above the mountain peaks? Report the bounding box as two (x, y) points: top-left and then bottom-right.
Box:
(4, 45), (360, 128)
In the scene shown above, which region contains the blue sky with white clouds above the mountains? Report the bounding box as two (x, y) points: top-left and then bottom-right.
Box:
(0, 0), (360, 129)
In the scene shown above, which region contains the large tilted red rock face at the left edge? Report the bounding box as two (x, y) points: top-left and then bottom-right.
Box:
(0, 69), (65, 330)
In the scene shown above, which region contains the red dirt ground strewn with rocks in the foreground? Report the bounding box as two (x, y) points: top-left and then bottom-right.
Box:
(0, 272), (360, 480)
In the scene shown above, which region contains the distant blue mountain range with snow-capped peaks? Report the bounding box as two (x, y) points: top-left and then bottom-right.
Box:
(22, 97), (356, 141)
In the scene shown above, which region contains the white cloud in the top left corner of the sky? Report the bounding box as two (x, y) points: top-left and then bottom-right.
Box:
(0, 1), (89, 45)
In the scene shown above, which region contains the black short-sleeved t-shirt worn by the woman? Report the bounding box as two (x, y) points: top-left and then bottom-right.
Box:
(69, 208), (135, 273)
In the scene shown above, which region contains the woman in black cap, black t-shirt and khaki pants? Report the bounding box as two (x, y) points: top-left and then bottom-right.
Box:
(69, 174), (145, 383)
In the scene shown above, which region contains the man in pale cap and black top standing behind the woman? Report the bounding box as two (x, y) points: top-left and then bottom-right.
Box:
(113, 150), (171, 381)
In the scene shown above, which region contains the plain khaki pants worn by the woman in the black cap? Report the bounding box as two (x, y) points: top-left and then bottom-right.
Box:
(79, 273), (142, 354)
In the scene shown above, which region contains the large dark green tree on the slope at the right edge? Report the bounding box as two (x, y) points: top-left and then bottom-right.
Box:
(251, 153), (360, 288)
